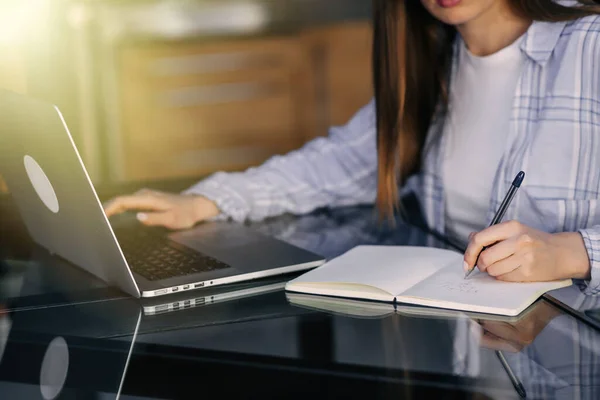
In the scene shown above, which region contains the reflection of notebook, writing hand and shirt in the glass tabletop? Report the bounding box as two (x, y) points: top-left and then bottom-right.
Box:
(288, 295), (600, 399)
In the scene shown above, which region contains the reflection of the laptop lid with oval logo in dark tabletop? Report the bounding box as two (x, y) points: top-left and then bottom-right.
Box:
(0, 304), (140, 400)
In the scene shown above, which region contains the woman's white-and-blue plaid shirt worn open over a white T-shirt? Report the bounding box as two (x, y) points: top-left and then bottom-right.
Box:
(185, 16), (600, 294)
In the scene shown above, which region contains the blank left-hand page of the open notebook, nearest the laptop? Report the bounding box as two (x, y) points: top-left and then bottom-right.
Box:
(286, 246), (462, 301)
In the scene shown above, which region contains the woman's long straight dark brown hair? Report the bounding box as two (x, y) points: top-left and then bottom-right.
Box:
(373, 0), (600, 218)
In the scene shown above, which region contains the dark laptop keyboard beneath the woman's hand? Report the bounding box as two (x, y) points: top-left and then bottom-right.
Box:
(114, 227), (230, 281)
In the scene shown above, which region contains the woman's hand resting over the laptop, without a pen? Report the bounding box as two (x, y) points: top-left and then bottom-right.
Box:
(104, 189), (219, 229)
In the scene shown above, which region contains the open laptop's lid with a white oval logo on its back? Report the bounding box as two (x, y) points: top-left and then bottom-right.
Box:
(0, 90), (140, 297)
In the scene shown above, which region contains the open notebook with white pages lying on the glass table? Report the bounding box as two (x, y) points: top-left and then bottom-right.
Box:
(285, 246), (572, 316)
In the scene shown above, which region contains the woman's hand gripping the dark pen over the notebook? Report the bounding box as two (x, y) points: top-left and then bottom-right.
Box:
(464, 221), (590, 282)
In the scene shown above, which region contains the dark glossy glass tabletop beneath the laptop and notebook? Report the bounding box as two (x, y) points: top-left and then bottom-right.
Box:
(0, 189), (600, 399)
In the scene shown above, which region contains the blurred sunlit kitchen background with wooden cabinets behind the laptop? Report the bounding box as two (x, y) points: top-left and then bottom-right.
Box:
(0, 0), (372, 194)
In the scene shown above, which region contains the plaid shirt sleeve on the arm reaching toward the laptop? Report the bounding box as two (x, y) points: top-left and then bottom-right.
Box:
(183, 101), (377, 222)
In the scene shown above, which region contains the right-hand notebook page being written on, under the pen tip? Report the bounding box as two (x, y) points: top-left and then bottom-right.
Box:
(397, 264), (571, 315)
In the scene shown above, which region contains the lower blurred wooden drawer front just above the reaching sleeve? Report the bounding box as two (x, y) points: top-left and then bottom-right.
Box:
(124, 96), (299, 178)
